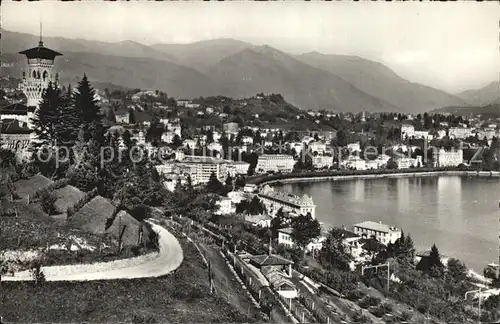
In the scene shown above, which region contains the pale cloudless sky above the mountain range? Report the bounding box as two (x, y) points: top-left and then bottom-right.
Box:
(1, 0), (500, 93)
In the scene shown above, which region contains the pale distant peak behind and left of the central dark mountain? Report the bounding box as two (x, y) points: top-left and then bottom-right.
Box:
(151, 38), (252, 72)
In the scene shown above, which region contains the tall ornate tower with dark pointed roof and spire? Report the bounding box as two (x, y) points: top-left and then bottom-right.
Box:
(19, 23), (62, 118)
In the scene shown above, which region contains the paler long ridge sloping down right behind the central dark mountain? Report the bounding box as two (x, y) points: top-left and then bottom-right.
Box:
(297, 52), (467, 112)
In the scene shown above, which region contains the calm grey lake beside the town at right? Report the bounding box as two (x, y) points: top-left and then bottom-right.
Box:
(274, 176), (500, 273)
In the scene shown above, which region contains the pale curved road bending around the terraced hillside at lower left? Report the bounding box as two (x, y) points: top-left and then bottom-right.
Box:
(2, 222), (183, 281)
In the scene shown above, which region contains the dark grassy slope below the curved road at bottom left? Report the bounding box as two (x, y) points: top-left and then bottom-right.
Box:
(0, 230), (249, 323)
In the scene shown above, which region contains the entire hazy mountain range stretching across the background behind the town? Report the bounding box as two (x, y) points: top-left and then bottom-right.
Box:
(2, 30), (498, 113)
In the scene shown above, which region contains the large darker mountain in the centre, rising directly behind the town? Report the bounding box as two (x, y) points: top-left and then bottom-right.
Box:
(208, 46), (399, 111)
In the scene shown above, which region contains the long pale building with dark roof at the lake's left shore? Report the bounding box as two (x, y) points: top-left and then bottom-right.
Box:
(258, 185), (316, 218)
